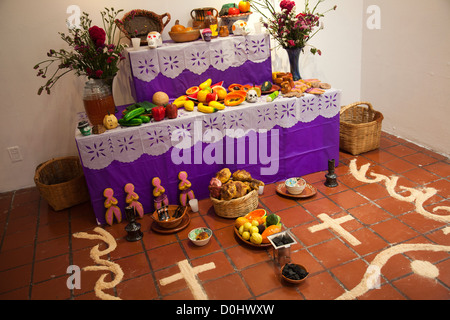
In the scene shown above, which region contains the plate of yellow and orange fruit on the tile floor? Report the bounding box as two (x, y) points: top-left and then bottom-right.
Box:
(234, 209), (281, 247)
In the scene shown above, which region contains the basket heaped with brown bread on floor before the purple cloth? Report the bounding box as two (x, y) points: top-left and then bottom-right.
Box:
(209, 168), (264, 218)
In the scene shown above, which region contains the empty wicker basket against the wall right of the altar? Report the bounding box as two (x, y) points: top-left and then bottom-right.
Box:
(339, 102), (383, 155)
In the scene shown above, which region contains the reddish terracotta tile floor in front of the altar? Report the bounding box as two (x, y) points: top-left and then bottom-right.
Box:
(0, 133), (450, 300)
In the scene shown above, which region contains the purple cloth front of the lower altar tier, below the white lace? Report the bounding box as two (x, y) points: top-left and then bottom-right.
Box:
(78, 114), (339, 225)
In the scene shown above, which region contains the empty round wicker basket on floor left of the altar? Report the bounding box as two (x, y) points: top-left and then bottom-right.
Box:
(34, 157), (89, 211)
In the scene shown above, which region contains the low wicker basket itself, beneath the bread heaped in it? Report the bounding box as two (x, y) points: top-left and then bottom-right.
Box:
(211, 190), (259, 218)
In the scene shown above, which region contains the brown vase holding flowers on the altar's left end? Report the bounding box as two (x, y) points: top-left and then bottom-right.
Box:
(83, 79), (116, 126)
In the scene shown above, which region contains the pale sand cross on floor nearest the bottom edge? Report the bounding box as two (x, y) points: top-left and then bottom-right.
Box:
(159, 260), (216, 300)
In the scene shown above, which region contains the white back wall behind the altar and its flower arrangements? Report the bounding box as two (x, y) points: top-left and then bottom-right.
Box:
(0, 0), (384, 192)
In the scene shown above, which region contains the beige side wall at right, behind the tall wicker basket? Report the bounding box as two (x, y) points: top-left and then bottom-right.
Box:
(361, 0), (450, 157)
